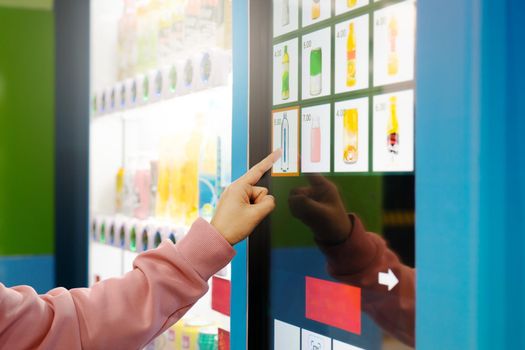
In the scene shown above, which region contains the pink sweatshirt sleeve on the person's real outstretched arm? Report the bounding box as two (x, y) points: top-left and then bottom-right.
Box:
(0, 219), (234, 350)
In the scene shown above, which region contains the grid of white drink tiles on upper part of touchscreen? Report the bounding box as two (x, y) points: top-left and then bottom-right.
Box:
(271, 0), (416, 176)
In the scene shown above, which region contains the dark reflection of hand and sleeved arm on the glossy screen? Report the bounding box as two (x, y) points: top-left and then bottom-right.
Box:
(289, 175), (415, 346)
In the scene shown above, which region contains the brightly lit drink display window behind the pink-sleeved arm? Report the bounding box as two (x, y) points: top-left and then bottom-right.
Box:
(88, 0), (232, 349)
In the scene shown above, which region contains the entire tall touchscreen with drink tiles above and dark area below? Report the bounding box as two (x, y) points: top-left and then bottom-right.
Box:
(267, 0), (416, 350)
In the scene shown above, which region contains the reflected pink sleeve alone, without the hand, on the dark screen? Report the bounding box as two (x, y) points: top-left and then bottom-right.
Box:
(320, 215), (415, 346)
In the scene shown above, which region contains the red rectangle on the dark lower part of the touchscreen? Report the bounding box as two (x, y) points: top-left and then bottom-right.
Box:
(306, 277), (361, 335)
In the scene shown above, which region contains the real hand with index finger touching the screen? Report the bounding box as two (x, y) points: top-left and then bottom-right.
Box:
(211, 150), (281, 245)
